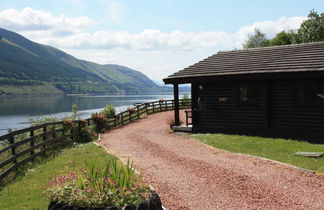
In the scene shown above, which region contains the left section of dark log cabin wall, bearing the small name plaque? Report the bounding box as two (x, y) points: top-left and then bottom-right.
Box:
(193, 82), (267, 133)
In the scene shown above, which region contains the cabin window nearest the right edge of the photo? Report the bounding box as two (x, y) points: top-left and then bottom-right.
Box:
(296, 80), (319, 105)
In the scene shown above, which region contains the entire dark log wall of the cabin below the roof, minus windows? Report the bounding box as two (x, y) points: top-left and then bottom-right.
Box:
(192, 80), (324, 143)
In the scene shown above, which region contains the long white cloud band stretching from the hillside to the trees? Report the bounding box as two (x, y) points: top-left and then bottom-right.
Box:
(25, 17), (305, 51)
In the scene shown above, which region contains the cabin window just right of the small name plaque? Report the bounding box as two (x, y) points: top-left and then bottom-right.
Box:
(239, 83), (259, 105)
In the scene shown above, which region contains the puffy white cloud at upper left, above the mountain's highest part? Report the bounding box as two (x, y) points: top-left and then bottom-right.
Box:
(0, 7), (93, 36)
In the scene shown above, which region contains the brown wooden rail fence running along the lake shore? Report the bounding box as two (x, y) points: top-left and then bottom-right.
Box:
(0, 99), (191, 183)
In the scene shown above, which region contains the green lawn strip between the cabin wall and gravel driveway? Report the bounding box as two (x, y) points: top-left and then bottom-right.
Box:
(191, 134), (324, 174)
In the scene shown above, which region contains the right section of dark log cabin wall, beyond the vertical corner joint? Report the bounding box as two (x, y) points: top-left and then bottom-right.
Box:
(272, 80), (324, 143)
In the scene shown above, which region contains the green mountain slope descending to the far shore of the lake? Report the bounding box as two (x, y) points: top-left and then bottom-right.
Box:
(0, 28), (163, 95)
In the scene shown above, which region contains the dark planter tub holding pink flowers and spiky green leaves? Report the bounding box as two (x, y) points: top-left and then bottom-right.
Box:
(48, 192), (163, 210)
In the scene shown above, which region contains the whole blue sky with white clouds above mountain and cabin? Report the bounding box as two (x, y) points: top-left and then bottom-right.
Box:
(0, 0), (324, 83)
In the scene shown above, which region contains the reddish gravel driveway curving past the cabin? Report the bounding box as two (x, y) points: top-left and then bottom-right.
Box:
(100, 111), (324, 210)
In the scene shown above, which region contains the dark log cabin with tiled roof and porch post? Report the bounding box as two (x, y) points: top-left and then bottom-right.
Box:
(163, 42), (324, 143)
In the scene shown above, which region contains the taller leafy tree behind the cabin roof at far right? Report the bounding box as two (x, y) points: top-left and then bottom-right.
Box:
(296, 10), (324, 43)
